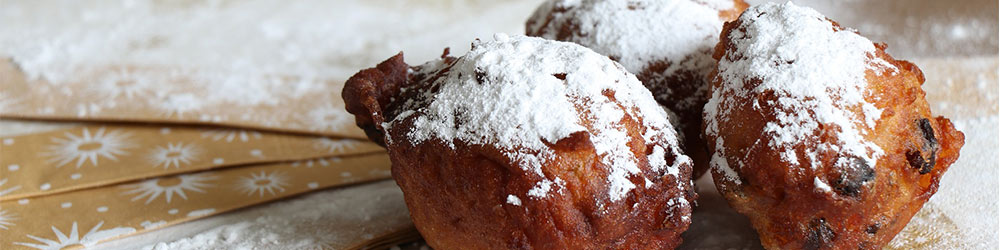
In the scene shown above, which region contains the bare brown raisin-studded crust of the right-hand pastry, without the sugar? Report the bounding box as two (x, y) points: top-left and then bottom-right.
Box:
(706, 11), (964, 249)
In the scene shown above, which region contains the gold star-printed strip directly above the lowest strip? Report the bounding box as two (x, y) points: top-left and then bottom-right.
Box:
(0, 125), (384, 201)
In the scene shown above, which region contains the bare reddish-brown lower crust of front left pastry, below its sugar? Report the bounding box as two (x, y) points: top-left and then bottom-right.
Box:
(390, 118), (693, 249)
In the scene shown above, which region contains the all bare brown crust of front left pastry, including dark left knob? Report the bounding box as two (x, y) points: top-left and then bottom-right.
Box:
(344, 51), (696, 249)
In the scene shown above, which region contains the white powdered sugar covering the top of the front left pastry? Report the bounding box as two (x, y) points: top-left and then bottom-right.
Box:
(383, 34), (690, 202)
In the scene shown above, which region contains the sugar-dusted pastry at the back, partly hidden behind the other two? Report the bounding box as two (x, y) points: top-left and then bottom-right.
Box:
(525, 0), (747, 178)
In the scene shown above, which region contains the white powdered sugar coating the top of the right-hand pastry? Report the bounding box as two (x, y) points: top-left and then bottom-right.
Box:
(705, 2), (895, 182)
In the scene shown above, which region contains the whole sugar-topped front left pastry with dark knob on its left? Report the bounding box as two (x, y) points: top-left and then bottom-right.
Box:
(343, 34), (695, 249)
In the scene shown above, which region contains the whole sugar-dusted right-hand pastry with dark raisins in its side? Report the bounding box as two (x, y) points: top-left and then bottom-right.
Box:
(705, 3), (964, 249)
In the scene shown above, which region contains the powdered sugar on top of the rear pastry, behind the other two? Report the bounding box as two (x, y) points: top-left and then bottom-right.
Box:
(527, 0), (733, 111)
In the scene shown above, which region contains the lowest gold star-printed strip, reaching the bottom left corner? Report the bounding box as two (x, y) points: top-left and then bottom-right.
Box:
(0, 153), (390, 249)
